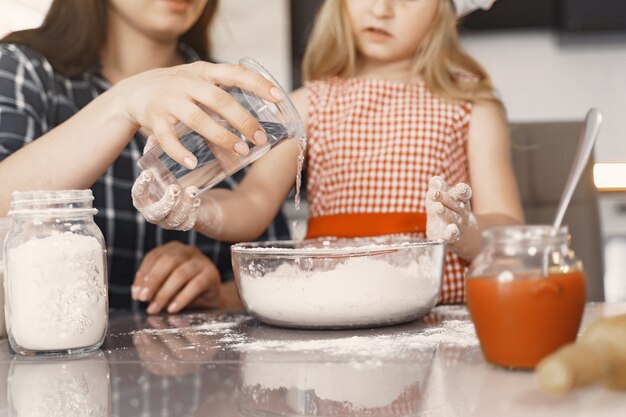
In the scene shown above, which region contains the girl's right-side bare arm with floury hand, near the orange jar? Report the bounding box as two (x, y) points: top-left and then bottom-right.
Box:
(426, 100), (524, 261)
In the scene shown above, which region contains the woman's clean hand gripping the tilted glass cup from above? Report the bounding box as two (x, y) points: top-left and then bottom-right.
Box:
(116, 61), (284, 169)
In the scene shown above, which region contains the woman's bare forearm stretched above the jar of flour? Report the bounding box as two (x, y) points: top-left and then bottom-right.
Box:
(0, 88), (138, 216)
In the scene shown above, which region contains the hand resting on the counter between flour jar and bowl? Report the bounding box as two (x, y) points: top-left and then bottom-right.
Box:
(131, 241), (221, 314)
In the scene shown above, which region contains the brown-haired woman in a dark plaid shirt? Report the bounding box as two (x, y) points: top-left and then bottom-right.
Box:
(0, 0), (287, 313)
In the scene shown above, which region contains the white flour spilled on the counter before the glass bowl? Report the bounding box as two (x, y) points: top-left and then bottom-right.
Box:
(122, 307), (478, 362)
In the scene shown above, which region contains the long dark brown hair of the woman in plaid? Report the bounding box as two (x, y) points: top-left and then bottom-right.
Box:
(0, 0), (218, 77)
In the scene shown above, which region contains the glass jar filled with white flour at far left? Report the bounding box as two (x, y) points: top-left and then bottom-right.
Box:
(4, 190), (108, 355)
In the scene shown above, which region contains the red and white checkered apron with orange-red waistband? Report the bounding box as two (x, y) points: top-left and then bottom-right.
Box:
(306, 78), (472, 304)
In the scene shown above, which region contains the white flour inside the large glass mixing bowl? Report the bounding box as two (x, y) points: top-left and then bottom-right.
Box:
(240, 256), (440, 327)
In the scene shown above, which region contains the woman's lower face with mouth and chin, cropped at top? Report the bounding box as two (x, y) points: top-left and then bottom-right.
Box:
(109, 0), (208, 40)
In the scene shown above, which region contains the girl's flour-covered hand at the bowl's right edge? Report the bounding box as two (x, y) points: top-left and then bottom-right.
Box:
(426, 177), (480, 258)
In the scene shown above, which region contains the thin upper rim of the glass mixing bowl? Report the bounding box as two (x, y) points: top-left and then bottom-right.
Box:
(230, 237), (445, 257)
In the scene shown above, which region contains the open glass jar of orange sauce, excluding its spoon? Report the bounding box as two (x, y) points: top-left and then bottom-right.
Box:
(466, 225), (585, 369)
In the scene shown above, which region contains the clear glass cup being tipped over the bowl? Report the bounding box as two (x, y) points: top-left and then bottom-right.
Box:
(137, 58), (305, 199)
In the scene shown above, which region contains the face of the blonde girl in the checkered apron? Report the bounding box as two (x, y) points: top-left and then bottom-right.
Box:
(344, 0), (436, 62)
